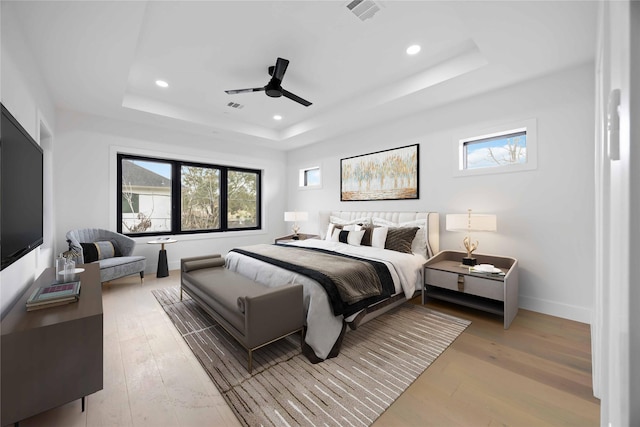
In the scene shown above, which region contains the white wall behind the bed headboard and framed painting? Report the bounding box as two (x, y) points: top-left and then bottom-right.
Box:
(287, 64), (594, 323)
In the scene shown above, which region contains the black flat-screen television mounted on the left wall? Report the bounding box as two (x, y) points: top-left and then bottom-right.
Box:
(0, 104), (43, 270)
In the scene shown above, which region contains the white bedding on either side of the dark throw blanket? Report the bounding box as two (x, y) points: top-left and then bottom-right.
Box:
(226, 239), (427, 359)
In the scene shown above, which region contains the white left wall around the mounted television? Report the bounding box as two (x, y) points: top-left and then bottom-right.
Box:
(0, 2), (55, 316)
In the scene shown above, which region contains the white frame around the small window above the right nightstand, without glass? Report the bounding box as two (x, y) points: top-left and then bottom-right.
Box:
(452, 119), (538, 176)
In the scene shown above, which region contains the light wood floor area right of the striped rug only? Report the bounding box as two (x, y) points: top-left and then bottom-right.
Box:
(374, 298), (600, 427)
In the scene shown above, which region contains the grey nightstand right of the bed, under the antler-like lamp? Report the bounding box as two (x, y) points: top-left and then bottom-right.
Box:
(422, 251), (518, 329)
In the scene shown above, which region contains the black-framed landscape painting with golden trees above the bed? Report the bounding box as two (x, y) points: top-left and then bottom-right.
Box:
(340, 144), (419, 201)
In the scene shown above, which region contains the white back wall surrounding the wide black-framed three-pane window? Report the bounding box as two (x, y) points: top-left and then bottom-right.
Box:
(54, 111), (286, 273)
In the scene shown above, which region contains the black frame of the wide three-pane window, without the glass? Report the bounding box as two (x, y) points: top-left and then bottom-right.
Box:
(116, 152), (263, 237)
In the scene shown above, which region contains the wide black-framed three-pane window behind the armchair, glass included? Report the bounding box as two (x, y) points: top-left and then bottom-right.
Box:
(117, 154), (261, 236)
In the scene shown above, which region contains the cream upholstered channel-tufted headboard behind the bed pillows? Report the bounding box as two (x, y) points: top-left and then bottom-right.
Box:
(318, 211), (440, 257)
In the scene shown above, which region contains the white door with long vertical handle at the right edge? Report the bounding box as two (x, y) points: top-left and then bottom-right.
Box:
(592, 1), (640, 426)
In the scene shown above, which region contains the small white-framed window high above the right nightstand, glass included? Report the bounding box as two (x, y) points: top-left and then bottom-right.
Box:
(455, 120), (536, 175)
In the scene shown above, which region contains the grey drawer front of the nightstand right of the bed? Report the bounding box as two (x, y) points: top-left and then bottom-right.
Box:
(424, 268), (504, 301)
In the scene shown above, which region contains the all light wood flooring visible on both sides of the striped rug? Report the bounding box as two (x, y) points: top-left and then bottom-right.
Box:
(20, 271), (600, 427)
